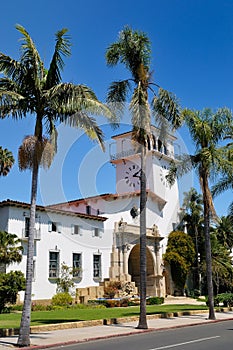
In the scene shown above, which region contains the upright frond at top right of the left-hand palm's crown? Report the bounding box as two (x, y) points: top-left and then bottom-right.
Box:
(45, 28), (71, 89)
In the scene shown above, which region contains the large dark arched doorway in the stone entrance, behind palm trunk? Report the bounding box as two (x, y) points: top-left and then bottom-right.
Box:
(128, 244), (155, 294)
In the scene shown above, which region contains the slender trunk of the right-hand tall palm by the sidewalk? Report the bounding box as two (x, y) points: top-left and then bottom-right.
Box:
(202, 174), (215, 320)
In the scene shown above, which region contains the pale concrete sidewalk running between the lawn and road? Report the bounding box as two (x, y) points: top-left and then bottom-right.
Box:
(0, 300), (233, 350)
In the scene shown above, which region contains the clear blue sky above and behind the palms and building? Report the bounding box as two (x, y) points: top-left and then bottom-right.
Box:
(0, 0), (233, 215)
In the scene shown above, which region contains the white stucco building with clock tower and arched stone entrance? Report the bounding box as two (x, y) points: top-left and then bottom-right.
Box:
(0, 127), (179, 300)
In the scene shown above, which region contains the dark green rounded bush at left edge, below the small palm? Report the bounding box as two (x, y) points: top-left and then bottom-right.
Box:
(0, 271), (26, 313)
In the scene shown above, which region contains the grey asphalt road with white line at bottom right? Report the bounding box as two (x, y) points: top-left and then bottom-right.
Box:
(47, 321), (233, 350)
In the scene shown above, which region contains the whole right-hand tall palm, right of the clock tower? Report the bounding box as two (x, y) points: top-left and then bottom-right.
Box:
(167, 108), (232, 319)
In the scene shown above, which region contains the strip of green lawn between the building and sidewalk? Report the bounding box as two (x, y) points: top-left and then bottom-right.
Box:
(0, 305), (207, 328)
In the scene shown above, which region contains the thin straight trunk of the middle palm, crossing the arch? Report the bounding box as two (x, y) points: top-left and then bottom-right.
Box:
(137, 145), (148, 329)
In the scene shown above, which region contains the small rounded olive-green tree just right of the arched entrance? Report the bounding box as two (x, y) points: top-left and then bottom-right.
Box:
(164, 231), (195, 294)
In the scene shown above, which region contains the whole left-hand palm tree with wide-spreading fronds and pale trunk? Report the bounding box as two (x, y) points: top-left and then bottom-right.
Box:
(0, 25), (112, 346)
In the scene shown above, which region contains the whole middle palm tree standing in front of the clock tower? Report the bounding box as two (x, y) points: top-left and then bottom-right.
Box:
(106, 27), (180, 329)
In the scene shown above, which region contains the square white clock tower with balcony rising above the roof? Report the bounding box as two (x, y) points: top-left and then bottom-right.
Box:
(110, 126), (178, 201)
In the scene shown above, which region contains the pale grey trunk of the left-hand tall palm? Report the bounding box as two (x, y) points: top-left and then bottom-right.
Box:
(17, 164), (39, 347)
